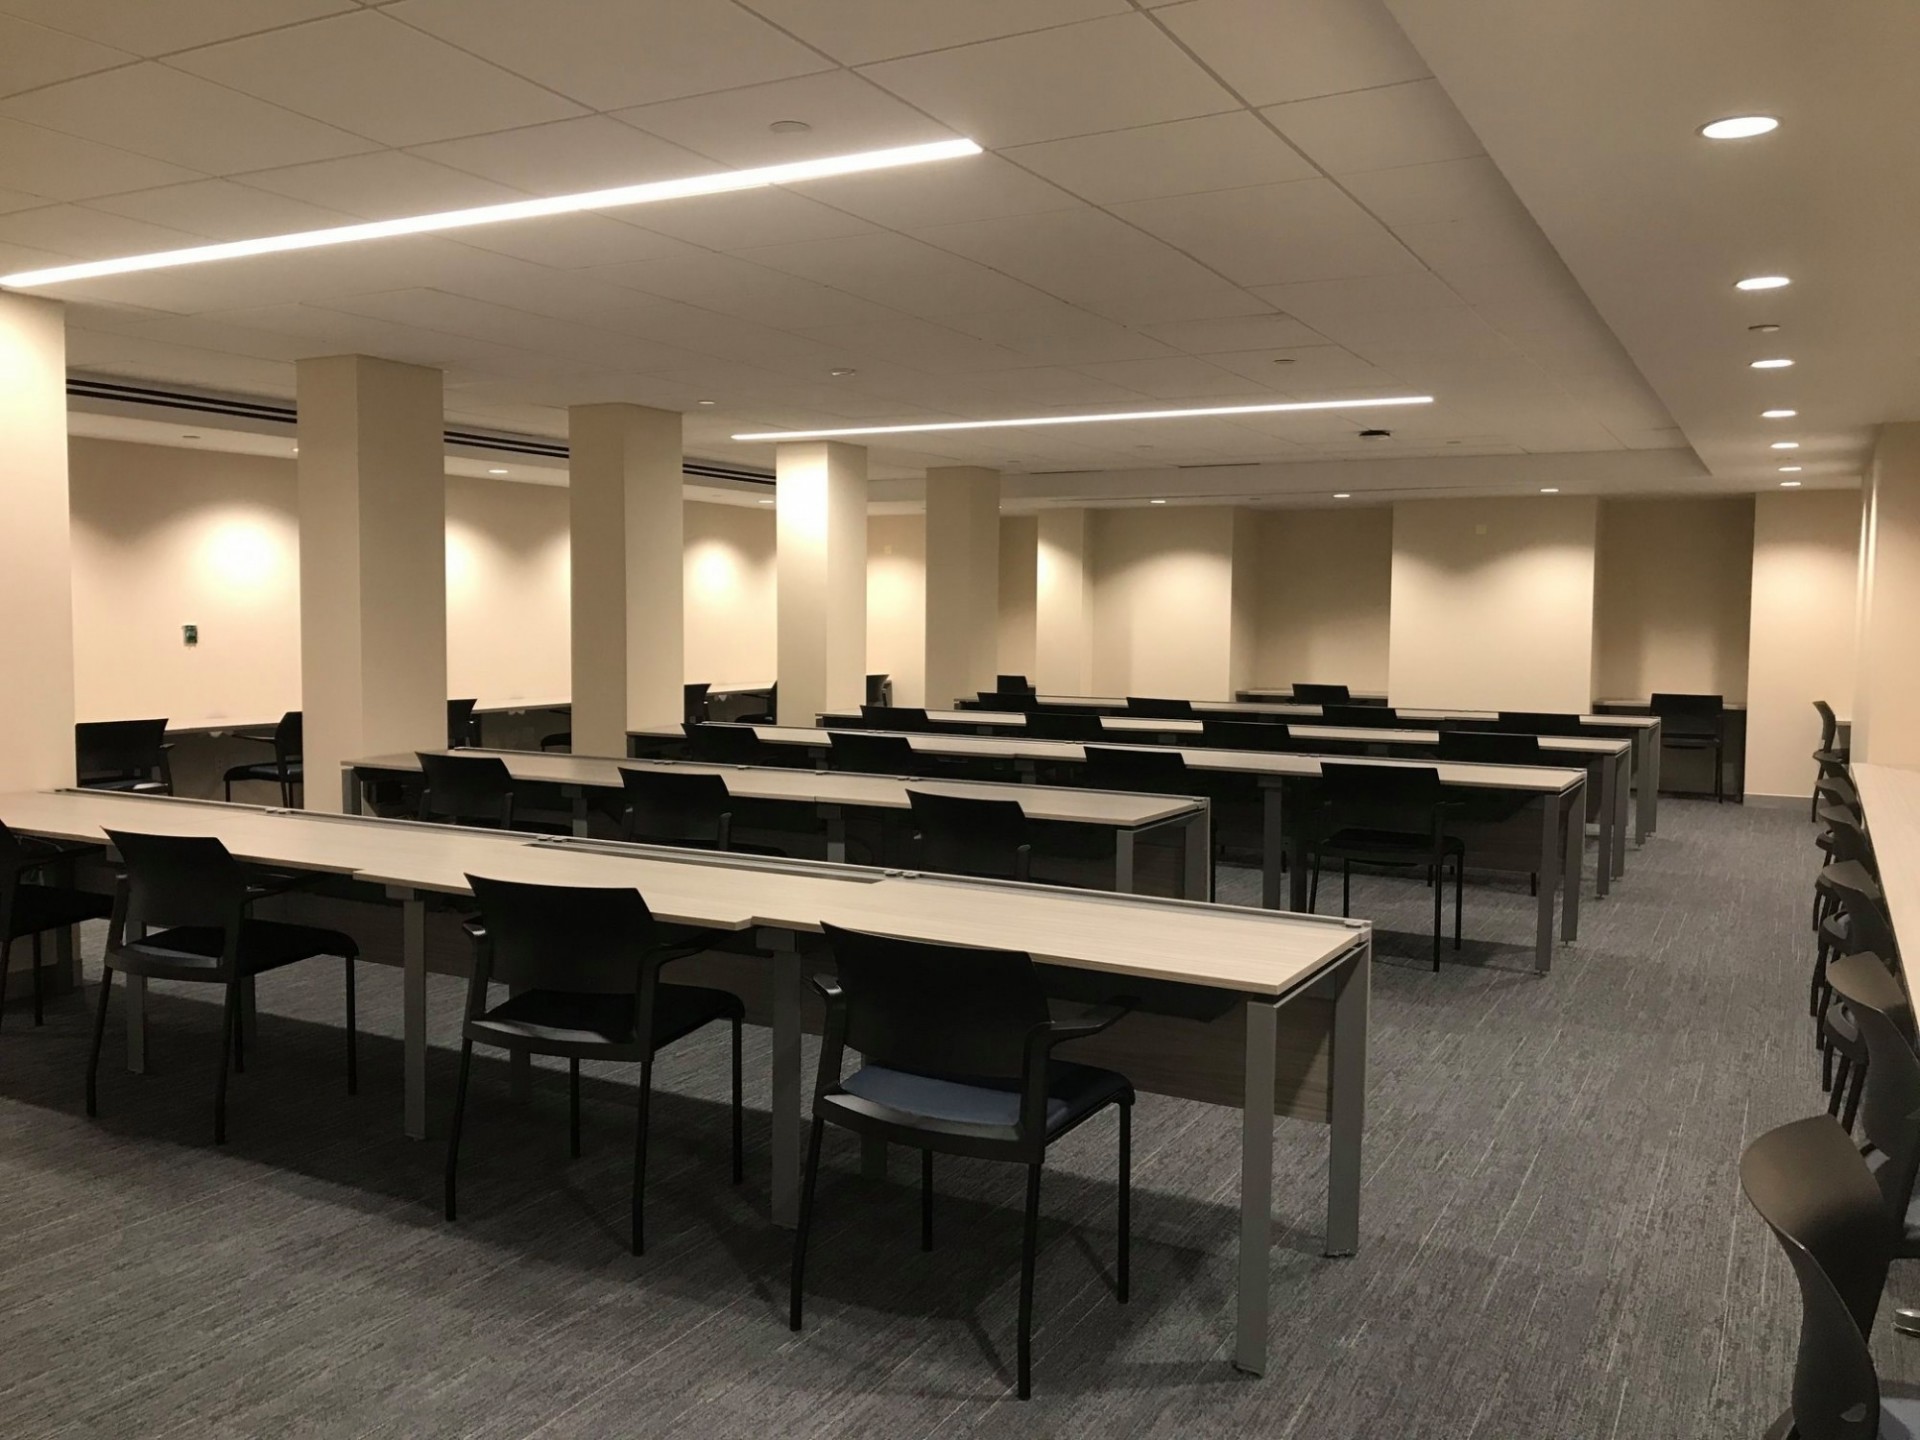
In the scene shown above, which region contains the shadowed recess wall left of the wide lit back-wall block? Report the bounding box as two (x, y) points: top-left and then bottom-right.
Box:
(1248, 505), (1394, 691)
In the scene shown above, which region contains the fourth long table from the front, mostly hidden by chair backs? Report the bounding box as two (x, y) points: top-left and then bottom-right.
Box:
(814, 710), (1634, 897)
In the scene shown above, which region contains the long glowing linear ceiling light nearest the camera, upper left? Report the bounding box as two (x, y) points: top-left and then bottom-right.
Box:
(0, 140), (981, 290)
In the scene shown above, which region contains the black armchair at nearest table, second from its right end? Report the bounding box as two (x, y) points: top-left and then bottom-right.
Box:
(445, 876), (745, 1256)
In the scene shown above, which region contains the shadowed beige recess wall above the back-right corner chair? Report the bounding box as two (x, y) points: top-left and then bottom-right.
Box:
(1594, 495), (1753, 701)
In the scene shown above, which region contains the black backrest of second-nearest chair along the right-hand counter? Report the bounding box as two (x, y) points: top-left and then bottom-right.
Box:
(1826, 954), (1920, 1225)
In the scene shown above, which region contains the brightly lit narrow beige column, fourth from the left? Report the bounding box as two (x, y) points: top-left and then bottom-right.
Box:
(774, 442), (866, 726)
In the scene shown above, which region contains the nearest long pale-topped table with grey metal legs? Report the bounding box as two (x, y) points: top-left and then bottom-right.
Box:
(0, 791), (1373, 1375)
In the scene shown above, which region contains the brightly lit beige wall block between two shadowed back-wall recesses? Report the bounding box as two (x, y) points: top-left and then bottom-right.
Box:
(1388, 495), (1599, 710)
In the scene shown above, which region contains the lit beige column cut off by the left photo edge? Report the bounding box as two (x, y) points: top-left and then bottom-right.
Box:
(0, 292), (73, 789)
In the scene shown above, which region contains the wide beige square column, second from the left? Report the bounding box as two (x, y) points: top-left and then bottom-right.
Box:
(298, 355), (447, 810)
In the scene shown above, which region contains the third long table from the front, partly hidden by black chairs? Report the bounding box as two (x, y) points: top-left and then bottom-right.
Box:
(648, 726), (1586, 975)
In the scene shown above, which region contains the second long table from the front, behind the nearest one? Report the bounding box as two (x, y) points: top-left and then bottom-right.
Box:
(342, 749), (1213, 900)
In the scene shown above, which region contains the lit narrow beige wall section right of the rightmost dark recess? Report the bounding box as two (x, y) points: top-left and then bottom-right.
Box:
(1747, 490), (1860, 797)
